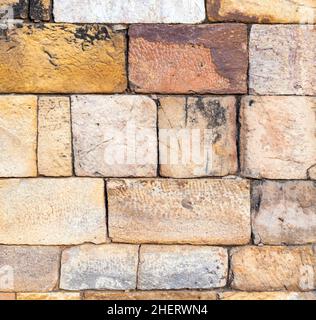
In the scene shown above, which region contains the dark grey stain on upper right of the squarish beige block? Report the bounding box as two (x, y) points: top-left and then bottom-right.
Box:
(192, 97), (227, 129)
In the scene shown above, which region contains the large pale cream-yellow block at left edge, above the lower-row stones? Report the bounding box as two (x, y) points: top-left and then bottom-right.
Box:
(0, 178), (106, 245)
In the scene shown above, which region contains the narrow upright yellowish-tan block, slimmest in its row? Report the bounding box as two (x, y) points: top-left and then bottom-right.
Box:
(37, 97), (72, 177)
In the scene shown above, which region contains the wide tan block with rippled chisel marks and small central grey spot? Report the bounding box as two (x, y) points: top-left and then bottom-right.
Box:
(107, 179), (251, 245)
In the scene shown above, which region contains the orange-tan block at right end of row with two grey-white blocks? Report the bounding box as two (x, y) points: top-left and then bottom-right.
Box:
(231, 246), (316, 291)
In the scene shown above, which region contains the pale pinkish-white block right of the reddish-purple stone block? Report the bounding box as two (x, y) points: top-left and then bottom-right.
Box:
(249, 25), (316, 95)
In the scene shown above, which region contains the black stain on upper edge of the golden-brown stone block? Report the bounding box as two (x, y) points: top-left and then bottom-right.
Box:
(74, 25), (111, 44)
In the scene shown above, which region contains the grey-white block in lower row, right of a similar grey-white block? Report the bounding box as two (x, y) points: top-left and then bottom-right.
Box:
(138, 245), (228, 290)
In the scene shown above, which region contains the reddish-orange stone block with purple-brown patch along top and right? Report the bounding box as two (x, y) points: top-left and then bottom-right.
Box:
(129, 24), (248, 94)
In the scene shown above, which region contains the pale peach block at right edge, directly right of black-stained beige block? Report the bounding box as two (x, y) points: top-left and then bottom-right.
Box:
(240, 96), (316, 179)
